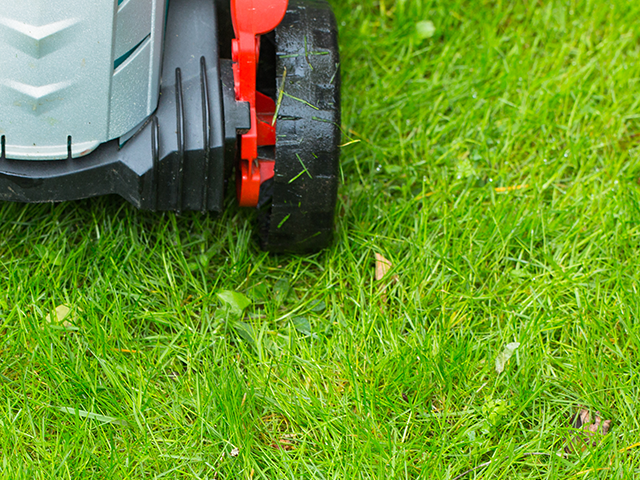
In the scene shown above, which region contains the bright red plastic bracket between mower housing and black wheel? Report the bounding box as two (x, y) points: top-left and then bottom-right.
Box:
(231, 0), (288, 207)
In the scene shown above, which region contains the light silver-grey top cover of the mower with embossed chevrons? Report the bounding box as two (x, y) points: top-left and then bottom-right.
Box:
(0, 0), (167, 160)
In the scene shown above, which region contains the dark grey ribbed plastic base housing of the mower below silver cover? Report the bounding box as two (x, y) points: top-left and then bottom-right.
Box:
(0, 0), (250, 212)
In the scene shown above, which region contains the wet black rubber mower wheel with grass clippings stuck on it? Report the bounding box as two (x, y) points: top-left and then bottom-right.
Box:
(259, 0), (341, 253)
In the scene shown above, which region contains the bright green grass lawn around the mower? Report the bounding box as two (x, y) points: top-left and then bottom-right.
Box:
(0, 0), (640, 479)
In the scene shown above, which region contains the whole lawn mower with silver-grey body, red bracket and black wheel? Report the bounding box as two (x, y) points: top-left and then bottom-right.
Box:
(0, 0), (340, 252)
